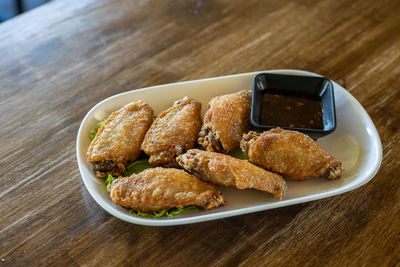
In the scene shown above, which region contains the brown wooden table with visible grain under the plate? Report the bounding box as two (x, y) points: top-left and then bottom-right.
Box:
(0, 0), (400, 266)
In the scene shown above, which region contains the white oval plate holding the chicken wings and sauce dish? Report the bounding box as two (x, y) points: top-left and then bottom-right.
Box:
(76, 70), (382, 226)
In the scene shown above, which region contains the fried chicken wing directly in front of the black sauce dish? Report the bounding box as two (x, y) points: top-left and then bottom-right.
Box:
(240, 128), (344, 180)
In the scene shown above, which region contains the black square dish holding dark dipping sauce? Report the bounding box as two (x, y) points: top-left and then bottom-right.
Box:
(251, 73), (336, 139)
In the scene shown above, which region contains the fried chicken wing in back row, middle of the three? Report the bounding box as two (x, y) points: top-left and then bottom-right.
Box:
(141, 97), (202, 167)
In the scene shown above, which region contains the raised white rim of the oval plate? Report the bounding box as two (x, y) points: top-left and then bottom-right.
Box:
(76, 69), (383, 226)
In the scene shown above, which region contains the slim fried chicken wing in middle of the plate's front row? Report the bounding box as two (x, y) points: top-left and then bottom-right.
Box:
(177, 149), (286, 200)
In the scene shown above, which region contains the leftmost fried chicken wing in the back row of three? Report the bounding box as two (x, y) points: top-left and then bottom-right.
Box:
(87, 100), (153, 178)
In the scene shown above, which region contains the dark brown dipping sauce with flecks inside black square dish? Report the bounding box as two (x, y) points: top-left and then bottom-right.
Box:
(260, 90), (324, 129)
